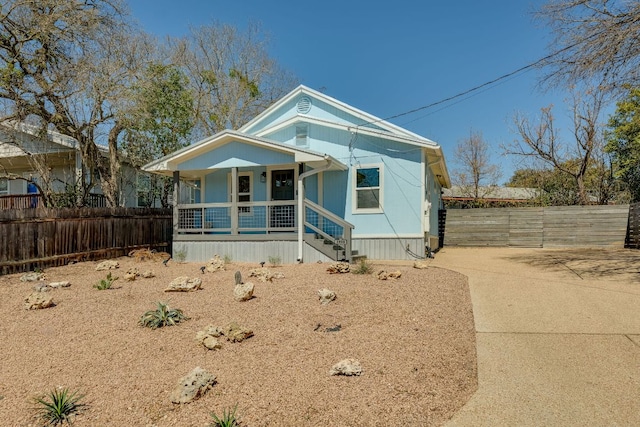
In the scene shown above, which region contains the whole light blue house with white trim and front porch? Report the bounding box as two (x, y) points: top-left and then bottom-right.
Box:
(143, 86), (450, 263)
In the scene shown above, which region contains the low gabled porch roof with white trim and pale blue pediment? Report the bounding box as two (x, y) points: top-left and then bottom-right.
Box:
(142, 131), (347, 179)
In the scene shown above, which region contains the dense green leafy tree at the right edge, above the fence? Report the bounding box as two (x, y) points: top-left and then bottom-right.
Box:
(606, 87), (640, 202)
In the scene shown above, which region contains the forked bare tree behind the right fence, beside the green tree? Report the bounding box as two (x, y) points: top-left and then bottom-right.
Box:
(505, 86), (604, 205)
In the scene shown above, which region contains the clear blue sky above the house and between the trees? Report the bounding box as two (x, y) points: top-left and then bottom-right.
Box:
(128, 0), (569, 182)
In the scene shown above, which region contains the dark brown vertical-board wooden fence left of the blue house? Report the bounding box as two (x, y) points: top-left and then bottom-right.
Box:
(0, 208), (173, 274)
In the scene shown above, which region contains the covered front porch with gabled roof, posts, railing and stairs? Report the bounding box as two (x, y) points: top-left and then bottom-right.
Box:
(145, 131), (353, 262)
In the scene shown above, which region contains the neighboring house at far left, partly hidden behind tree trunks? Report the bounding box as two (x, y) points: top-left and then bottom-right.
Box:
(0, 122), (159, 209)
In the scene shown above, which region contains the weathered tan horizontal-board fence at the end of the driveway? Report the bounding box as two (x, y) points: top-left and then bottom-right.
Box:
(444, 205), (629, 248)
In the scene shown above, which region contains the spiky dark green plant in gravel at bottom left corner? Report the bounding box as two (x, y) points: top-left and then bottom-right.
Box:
(35, 388), (87, 426)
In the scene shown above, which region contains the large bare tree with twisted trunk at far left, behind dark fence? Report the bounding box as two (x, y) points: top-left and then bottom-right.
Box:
(0, 0), (154, 206)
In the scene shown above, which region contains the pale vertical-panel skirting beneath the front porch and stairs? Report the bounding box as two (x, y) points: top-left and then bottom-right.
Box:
(173, 241), (332, 265)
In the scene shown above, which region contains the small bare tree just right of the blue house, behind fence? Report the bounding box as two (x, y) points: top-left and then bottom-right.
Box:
(454, 131), (502, 199)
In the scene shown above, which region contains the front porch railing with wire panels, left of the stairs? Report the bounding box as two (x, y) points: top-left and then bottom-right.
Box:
(177, 200), (297, 234)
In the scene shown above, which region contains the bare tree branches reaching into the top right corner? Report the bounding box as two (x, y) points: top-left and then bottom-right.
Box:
(537, 0), (640, 89)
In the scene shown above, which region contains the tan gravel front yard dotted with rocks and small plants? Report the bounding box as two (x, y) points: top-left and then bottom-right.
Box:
(0, 257), (477, 427)
